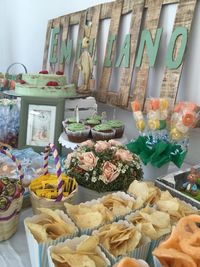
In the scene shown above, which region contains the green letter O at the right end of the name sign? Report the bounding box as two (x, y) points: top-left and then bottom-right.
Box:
(165, 27), (188, 69)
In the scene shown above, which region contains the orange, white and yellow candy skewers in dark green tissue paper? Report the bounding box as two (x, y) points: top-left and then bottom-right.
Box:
(127, 98), (199, 174)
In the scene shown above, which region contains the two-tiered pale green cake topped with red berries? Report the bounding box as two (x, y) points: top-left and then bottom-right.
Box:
(15, 73), (77, 98)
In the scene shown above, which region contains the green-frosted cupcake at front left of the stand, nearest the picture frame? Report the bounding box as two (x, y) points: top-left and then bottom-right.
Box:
(65, 123), (90, 143)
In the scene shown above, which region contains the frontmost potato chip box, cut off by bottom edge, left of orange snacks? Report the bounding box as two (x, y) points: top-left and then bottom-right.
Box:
(47, 235), (111, 267)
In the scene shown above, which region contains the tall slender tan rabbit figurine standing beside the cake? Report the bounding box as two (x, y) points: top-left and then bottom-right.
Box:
(77, 25), (93, 94)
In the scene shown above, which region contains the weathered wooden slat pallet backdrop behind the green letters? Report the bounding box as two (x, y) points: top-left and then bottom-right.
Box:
(43, 0), (197, 112)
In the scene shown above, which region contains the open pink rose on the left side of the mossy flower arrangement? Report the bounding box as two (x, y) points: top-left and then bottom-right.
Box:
(78, 152), (98, 171)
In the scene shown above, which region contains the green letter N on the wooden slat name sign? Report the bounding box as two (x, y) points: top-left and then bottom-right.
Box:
(136, 28), (162, 67)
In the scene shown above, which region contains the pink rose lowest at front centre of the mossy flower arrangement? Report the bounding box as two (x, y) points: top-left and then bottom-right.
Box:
(99, 161), (119, 184)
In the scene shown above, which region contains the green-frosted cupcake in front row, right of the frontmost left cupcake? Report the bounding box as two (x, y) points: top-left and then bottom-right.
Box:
(91, 123), (115, 141)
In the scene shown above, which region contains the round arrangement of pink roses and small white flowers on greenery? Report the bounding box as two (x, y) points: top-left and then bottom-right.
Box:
(65, 140), (143, 192)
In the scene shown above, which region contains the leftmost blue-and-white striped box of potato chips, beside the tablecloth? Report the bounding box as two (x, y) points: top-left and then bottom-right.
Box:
(24, 208), (79, 267)
